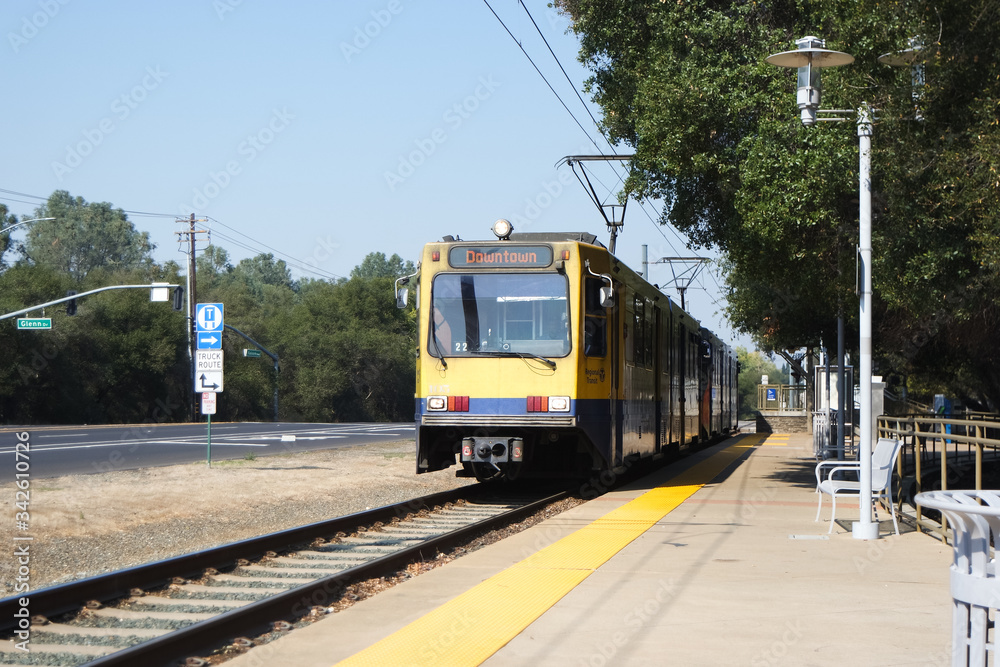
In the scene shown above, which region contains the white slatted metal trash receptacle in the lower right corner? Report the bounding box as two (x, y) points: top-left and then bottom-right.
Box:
(916, 491), (1000, 667)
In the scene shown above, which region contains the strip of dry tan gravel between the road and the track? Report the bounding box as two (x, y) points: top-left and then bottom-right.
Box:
(0, 440), (475, 597)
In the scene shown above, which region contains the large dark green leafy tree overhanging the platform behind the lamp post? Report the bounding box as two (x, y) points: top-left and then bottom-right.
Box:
(557, 0), (1000, 408)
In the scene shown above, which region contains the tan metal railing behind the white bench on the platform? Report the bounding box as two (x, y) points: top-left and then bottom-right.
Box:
(878, 414), (1000, 540)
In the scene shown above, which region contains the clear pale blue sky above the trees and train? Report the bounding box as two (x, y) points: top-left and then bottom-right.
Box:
(0, 0), (749, 346)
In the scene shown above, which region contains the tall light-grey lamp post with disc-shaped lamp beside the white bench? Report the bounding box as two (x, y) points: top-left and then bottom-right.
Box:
(766, 36), (878, 540)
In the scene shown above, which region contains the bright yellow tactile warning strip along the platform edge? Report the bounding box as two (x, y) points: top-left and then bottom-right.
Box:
(337, 434), (764, 666)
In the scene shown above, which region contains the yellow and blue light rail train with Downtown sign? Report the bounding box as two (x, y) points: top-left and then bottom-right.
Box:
(396, 220), (737, 480)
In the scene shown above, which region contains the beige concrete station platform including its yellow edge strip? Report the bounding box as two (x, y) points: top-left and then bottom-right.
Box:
(227, 434), (952, 667)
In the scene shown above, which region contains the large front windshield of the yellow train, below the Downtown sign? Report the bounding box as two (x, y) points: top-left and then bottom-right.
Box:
(427, 273), (570, 357)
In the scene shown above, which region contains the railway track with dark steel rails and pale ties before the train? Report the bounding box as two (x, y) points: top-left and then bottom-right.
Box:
(0, 484), (569, 667)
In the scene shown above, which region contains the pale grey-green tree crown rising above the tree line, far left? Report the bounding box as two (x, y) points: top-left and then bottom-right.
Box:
(24, 190), (155, 282)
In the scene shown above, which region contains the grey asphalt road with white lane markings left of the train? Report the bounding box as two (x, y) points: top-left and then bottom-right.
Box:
(0, 422), (414, 482)
